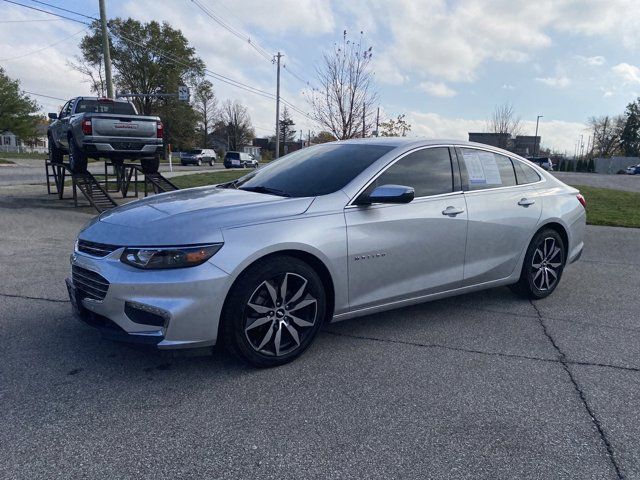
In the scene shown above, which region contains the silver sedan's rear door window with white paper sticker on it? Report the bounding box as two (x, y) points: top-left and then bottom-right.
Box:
(460, 148), (516, 190)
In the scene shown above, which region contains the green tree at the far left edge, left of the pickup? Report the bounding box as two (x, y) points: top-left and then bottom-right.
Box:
(0, 67), (39, 140)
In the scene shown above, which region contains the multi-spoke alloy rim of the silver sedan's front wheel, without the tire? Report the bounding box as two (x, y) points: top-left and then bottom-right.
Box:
(244, 272), (318, 357)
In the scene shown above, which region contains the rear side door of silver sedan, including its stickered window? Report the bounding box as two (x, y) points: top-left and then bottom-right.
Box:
(456, 147), (542, 285)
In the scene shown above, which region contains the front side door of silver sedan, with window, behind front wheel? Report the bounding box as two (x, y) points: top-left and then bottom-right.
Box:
(345, 147), (467, 310)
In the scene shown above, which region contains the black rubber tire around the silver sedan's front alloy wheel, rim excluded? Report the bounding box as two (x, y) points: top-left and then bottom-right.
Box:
(222, 256), (327, 367)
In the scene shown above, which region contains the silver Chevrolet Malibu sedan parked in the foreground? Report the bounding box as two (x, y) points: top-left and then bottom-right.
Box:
(67, 138), (585, 367)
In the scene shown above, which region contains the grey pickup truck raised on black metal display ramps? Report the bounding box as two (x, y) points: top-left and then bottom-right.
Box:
(47, 97), (164, 173)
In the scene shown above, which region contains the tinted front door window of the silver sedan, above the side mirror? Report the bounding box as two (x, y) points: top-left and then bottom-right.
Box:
(376, 147), (453, 197)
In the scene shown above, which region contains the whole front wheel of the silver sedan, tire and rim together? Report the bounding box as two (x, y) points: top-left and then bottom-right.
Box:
(221, 255), (327, 367)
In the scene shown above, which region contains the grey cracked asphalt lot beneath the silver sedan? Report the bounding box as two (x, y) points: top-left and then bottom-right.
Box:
(0, 182), (640, 479)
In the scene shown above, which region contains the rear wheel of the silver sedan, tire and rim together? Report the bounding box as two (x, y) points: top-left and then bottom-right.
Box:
(510, 228), (566, 300)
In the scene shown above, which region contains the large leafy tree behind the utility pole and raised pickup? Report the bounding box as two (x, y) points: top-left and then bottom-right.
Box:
(72, 18), (204, 148)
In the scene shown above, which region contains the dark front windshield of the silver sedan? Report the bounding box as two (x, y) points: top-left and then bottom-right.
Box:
(233, 144), (395, 197)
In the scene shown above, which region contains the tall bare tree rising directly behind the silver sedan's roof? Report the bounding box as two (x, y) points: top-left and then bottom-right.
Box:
(310, 30), (377, 140)
